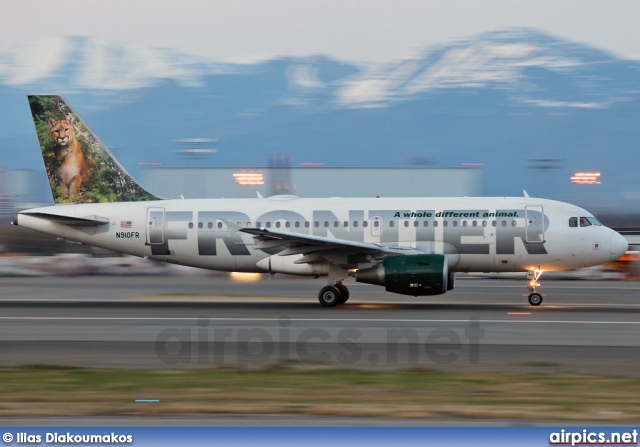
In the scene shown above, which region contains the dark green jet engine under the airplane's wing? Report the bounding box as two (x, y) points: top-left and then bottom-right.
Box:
(356, 254), (453, 296)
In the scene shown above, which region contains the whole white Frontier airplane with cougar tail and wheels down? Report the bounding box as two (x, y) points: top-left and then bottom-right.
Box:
(12, 95), (628, 307)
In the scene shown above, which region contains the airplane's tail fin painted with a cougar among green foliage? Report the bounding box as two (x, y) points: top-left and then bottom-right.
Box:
(28, 95), (160, 204)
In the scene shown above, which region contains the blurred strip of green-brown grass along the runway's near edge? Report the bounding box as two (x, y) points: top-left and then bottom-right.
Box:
(0, 366), (640, 422)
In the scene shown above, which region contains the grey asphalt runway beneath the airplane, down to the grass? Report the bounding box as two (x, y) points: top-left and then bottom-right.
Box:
(0, 274), (640, 376)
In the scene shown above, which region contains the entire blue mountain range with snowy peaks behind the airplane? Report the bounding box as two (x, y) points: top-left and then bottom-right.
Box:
(0, 29), (640, 209)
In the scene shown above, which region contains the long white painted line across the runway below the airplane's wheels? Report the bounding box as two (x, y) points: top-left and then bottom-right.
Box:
(0, 317), (640, 325)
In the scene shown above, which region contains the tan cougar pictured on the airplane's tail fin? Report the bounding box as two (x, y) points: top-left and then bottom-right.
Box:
(49, 115), (96, 197)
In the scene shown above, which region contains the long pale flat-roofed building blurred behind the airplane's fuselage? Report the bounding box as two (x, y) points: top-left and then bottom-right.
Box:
(141, 164), (482, 199)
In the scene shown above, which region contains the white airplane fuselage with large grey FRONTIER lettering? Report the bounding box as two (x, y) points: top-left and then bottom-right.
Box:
(17, 196), (627, 275)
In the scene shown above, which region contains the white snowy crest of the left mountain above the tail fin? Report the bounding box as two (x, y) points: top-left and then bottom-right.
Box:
(0, 37), (241, 90)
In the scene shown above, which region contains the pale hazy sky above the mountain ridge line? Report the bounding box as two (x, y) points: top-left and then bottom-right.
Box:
(0, 0), (640, 61)
